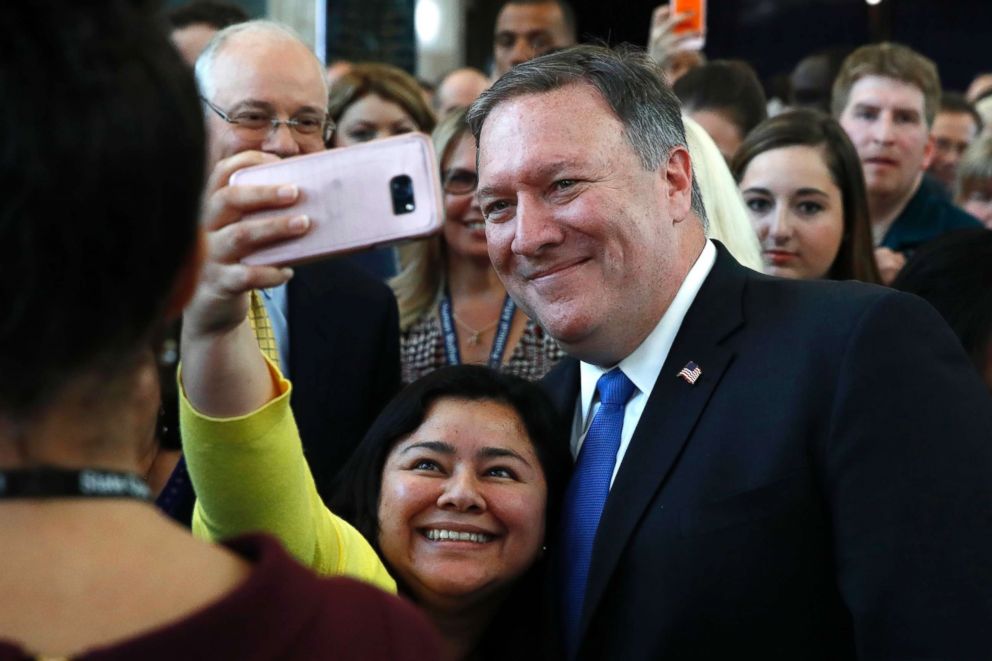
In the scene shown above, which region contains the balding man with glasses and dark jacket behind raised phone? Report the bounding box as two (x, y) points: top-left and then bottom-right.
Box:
(157, 21), (400, 521)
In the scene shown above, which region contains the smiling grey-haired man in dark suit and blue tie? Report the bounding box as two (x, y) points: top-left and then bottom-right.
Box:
(469, 47), (992, 659)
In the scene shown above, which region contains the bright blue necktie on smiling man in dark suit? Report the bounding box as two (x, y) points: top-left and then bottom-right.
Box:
(561, 369), (634, 658)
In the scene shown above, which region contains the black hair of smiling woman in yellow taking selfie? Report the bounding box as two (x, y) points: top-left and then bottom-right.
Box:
(331, 365), (571, 551)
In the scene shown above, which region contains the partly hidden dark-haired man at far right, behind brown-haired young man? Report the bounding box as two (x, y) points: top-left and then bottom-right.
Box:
(927, 92), (982, 195)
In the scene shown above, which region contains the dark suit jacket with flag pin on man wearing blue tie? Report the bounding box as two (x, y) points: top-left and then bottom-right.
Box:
(544, 247), (992, 660)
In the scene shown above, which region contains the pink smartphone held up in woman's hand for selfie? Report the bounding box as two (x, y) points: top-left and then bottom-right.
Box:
(231, 133), (444, 265)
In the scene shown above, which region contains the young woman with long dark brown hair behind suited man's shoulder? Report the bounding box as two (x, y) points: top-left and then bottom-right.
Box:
(732, 110), (879, 283)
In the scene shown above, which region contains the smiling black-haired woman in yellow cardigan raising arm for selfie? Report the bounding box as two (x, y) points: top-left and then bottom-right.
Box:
(180, 142), (571, 659)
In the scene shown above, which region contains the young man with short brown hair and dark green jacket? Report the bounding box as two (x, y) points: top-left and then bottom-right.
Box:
(831, 43), (979, 284)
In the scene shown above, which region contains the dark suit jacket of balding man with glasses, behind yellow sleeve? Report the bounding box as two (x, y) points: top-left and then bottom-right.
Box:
(287, 258), (400, 501)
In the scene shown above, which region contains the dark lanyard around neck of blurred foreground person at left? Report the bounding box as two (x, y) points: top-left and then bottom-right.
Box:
(0, 466), (151, 500)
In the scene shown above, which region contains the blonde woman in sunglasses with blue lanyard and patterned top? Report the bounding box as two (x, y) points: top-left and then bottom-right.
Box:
(390, 109), (564, 383)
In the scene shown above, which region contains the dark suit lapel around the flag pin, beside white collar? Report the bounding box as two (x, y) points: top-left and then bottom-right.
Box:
(573, 244), (746, 636)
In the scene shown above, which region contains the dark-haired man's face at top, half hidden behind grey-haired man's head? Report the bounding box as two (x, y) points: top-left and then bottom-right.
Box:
(492, 0), (578, 80)
